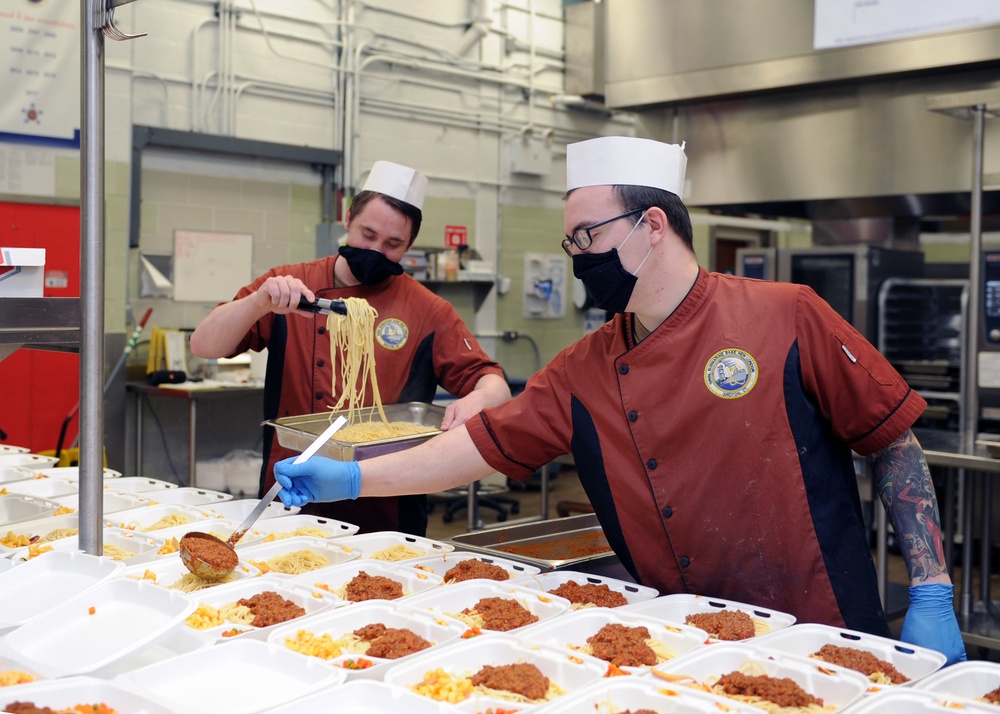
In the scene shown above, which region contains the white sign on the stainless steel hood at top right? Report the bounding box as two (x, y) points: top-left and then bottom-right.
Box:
(813, 0), (1000, 50)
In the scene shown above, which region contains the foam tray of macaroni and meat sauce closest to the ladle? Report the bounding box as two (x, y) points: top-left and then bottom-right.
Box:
(178, 575), (344, 642)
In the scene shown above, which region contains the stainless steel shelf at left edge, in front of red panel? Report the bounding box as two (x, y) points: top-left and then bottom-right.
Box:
(0, 298), (80, 360)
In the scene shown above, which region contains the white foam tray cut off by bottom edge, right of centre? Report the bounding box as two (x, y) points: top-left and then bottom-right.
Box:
(542, 677), (761, 714)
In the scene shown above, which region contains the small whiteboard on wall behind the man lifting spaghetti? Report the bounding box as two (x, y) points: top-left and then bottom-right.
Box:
(174, 231), (253, 303)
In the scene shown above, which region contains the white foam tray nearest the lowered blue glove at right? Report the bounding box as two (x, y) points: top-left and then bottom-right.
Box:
(753, 624), (948, 691)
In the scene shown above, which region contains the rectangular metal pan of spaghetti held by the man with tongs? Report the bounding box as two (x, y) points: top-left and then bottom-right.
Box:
(264, 402), (444, 461)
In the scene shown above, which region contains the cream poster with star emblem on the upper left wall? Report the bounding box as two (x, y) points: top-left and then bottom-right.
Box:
(0, 0), (80, 145)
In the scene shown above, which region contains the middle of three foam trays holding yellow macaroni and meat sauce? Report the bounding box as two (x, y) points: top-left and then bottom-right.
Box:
(267, 600), (466, 679)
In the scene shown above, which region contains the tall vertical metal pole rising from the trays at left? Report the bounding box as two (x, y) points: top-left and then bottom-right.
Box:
(79, 0), (104, 555)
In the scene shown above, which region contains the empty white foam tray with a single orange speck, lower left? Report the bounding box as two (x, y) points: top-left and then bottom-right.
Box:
(0, 568), (195, 677)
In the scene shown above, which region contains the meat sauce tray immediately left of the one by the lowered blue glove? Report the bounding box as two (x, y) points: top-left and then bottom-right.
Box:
(622, 593), (795, 641)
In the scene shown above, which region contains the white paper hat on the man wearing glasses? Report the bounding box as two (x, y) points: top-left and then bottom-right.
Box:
(566, 136), (687, 196)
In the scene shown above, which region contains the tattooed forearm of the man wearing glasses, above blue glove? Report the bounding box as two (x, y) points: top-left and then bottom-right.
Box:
(868, 429), (948, 584)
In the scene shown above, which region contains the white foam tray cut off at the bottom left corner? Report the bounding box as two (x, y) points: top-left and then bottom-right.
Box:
(0, 677), (171, 714)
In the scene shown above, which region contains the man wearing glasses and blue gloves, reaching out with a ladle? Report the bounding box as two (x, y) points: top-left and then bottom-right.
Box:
(275, 137), (965, 662)
